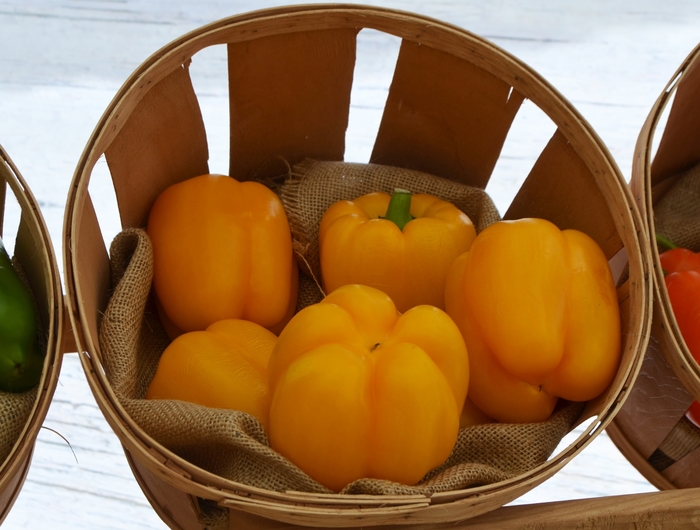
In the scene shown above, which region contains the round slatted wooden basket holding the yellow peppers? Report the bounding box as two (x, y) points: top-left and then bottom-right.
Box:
(64, 5), (652, 529)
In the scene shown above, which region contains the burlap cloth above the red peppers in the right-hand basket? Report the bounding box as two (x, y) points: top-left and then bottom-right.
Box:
(654, 160), (700, 252)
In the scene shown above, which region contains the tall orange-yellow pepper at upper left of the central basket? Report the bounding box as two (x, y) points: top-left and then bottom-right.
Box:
(147, 175), (298, 332)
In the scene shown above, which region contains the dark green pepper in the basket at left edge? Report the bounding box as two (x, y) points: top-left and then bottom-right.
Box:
(0, 236), (44, 392)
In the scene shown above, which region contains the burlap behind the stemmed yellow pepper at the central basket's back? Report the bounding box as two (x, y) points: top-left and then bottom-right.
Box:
(279, 159), (500, 296)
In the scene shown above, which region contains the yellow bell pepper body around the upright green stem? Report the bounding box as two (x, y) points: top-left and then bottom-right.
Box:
(319, 192), (476, 312)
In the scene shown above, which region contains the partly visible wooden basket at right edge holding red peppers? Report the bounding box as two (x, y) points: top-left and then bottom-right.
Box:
(608, 41), (700, 489)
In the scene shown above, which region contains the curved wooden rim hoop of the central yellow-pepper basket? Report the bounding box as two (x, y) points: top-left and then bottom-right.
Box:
(64, 6), (650, 525)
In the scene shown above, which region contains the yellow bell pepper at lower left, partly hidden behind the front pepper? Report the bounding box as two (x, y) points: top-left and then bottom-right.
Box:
(146, 319), (277, 428)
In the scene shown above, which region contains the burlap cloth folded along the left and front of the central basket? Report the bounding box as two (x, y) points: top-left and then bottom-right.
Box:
(100, 162), (582, 524)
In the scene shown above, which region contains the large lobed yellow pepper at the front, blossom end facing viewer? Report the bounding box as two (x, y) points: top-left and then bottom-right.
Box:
(268, 285), (469, 491)
